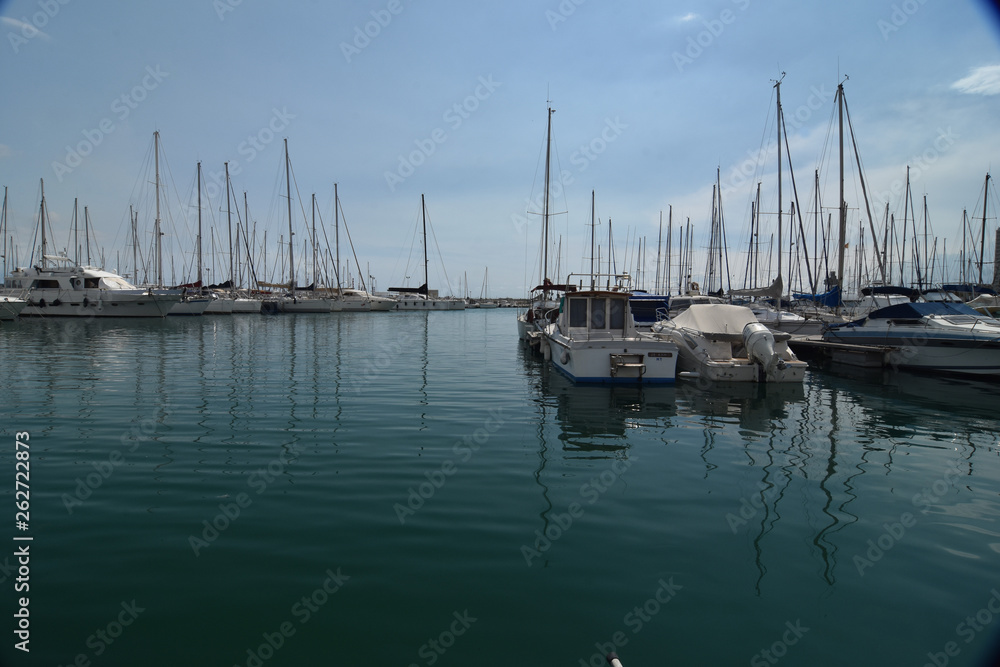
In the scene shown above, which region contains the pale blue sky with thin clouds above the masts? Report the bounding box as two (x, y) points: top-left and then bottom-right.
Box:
(0, 0), (1000, 296)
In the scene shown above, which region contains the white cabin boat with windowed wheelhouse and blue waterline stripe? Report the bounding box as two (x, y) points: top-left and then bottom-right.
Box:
(542, 274), (677, 384)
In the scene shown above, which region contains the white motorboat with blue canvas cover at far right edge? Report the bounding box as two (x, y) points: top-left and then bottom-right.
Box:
(823, 302), (1000, 378)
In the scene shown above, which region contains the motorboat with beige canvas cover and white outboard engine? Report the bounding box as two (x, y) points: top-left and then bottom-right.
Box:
(652, 304), (807, 383)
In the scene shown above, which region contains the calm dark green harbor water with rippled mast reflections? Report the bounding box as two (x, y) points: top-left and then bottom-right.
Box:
(0, 309), (1000, 667)
